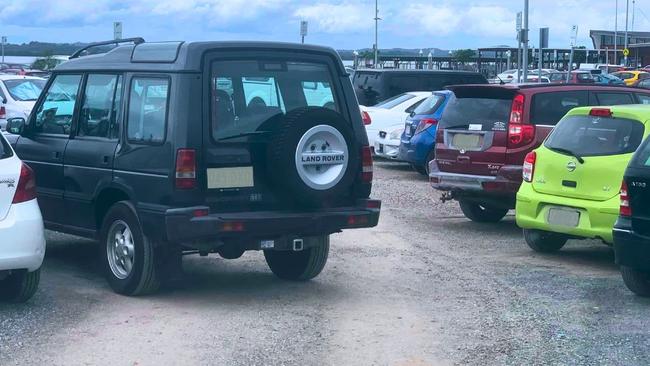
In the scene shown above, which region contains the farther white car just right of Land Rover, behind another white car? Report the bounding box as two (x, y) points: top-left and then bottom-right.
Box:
(359, 92), (432, 146)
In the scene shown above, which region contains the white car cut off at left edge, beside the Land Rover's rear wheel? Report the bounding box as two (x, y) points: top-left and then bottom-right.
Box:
(0, 133), (45, 302)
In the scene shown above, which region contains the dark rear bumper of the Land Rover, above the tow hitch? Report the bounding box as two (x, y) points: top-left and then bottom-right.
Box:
(165, 200), (381, 249)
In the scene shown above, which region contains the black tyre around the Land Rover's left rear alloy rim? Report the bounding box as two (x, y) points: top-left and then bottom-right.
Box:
(99, 201), (162, 296)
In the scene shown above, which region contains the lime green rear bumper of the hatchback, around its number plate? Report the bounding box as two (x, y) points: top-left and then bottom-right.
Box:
(516, 183), (620, 244)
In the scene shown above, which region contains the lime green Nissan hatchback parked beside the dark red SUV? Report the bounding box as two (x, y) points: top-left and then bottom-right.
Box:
(516, 105), (650, 252)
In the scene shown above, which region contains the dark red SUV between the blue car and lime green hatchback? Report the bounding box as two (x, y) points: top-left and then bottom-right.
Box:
(429, 84), (650, 222)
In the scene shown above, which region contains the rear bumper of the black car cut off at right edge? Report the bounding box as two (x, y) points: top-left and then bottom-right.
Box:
(612, 217), (650, 272)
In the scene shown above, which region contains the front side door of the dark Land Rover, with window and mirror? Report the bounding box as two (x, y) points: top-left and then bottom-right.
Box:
(15, 74), (81, 227)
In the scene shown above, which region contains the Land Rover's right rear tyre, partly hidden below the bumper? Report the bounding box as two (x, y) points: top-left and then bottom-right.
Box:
(264, 235), (330, 281)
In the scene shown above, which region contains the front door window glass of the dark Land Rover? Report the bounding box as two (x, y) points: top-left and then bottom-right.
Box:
(34, 75), (81, 135)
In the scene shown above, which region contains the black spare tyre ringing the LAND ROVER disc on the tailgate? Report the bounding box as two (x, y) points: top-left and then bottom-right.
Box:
(267, 107), (361, 206)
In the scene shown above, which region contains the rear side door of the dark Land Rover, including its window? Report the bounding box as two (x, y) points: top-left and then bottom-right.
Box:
(63, 74), (123, 231)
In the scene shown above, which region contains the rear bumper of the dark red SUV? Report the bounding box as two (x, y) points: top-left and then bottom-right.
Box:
(429, 160), (522, 194)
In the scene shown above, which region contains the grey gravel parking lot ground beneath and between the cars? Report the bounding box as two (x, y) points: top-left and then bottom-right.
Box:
(0, 162), (650, 365)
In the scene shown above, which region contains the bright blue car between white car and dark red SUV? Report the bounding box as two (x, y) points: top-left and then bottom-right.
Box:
(399, 90), (454, 176)
